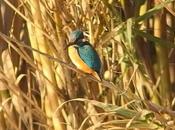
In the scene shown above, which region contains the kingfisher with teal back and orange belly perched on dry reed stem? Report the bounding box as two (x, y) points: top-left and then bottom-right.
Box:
(68, 29), (101, 81)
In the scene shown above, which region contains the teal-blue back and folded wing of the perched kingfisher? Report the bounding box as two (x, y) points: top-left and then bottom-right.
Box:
(77, 41), (101, 74)
